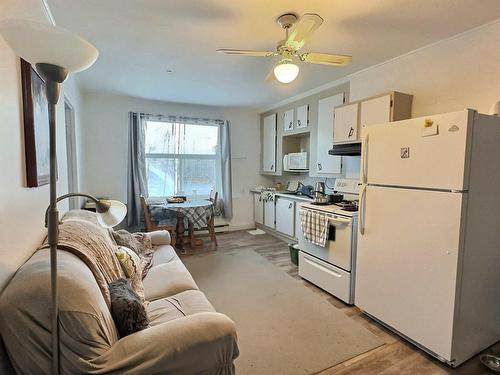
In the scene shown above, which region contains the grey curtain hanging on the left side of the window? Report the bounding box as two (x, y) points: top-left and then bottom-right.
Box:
(127, 112), (148, 227)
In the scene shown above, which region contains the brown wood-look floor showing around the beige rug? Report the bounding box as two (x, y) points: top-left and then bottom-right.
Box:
(181, 231), (500, 375)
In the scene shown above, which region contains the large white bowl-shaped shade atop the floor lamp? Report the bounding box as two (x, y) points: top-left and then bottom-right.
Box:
(0, 19), (99, 72)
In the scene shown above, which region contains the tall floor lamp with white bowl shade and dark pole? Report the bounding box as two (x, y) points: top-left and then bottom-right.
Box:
(0, 19), (100, 374)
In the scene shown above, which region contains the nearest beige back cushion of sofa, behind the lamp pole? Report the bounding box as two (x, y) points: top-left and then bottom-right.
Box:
(0, 249), (118, 374)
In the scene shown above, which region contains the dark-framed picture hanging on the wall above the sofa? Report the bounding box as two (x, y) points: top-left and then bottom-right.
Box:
(21, 59), (50, 187)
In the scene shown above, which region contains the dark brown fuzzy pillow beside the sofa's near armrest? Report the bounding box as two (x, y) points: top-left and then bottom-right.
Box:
(109, 279), (149, 337)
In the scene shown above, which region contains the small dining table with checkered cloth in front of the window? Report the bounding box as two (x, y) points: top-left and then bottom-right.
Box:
(153, 199), (213, 250)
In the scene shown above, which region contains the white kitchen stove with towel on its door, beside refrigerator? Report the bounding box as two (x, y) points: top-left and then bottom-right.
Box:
(299, 178), (359, 304)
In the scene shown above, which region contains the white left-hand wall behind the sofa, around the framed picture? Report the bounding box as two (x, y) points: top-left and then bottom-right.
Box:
(0, 37), (80, 290)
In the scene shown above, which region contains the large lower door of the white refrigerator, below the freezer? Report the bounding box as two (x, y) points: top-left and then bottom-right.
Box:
(355, 186), (465, 360)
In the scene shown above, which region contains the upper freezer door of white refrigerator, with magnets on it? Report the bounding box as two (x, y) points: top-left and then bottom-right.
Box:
(361, 111), (473, 191)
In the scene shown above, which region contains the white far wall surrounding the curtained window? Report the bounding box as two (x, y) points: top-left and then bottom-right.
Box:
(82, 92), (267, 230)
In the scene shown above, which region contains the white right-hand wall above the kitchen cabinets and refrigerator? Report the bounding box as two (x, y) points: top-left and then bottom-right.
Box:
(268, 20), (500, 183)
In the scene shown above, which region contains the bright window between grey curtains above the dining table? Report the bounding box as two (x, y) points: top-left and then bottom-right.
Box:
(145, 121), (221, 197)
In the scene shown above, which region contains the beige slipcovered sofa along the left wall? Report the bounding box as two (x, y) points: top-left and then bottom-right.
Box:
(0, 212), (238, 375)
